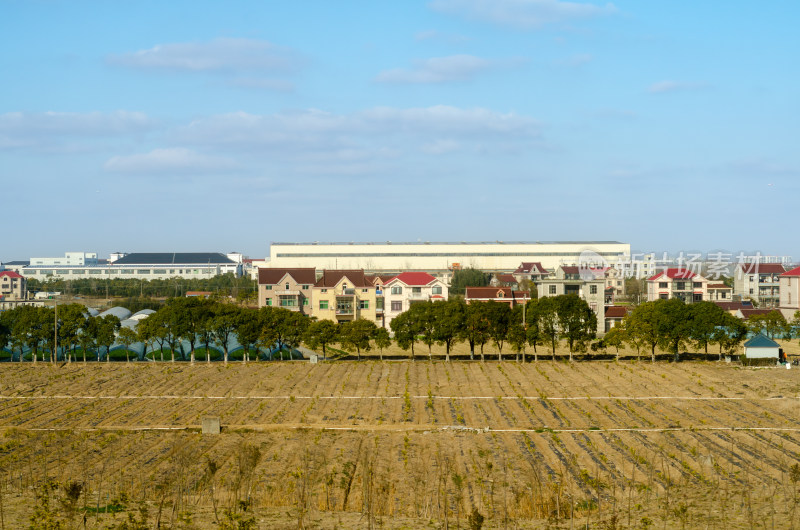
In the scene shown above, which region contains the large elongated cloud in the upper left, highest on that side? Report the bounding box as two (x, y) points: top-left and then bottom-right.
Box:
(108, 38), (302, 72)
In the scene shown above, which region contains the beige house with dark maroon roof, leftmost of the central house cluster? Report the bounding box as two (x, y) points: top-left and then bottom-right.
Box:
(258, 268), (317, 315)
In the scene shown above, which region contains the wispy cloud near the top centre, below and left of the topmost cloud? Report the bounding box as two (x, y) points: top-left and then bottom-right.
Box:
(375, 55), (493, 83)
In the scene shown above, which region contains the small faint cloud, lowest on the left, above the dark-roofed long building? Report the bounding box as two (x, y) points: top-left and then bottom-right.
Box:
(103, 147), (236, 175)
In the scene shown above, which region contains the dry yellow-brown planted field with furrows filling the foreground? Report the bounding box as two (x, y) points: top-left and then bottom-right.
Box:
(0, 346), (800, 530)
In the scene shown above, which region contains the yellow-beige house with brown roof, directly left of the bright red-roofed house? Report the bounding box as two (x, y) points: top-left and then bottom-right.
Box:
(311, 269), (383, 325)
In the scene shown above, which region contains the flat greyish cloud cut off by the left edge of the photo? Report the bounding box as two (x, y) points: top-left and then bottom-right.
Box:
(0, 110), (156, 151)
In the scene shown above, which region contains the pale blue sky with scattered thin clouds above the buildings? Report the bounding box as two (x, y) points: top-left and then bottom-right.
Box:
(0, 0), (800, 260)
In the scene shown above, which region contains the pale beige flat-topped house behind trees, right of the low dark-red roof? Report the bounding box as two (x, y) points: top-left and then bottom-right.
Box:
(537, 265), (606, 335)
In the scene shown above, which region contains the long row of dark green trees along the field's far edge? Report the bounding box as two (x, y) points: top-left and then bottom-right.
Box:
(0, 295), (788, 362)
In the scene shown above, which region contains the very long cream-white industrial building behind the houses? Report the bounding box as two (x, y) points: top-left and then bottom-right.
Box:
(264, 241), (631, 273)
